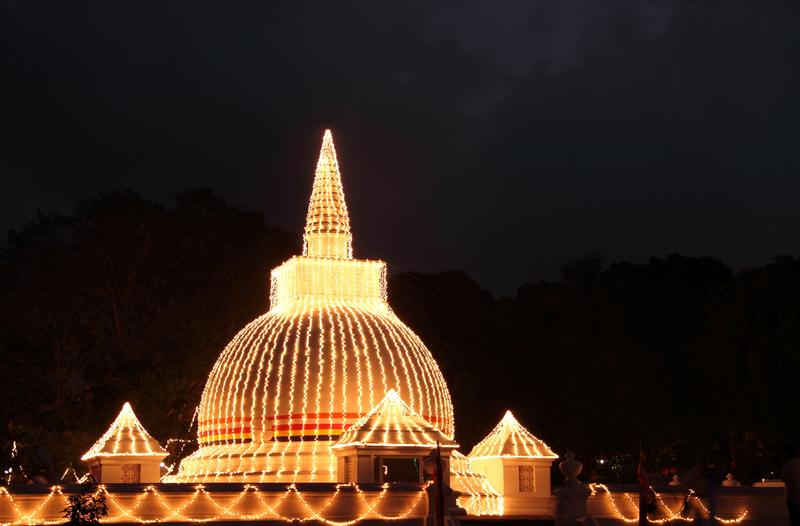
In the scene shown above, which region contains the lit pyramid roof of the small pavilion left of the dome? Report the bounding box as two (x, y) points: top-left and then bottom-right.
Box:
(81, 402), (168, 460)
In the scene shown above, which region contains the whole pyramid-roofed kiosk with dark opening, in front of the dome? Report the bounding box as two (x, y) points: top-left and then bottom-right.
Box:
(331, 389), (458, 483)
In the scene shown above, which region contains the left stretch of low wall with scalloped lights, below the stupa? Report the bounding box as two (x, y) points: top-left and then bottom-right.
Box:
(0, 483), (428, 524)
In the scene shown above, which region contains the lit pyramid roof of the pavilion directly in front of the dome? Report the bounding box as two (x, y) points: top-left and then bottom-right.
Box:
(331, 389), (458, 449)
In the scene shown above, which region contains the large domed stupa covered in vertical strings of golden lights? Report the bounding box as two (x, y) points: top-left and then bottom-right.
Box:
(170, 130), (454, 482)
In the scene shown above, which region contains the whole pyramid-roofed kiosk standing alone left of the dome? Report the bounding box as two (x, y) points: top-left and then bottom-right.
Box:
(81, 402), (168, 484)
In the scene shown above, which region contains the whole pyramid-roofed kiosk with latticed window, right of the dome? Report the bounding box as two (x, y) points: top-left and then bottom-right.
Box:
(468, 411), (558, 515)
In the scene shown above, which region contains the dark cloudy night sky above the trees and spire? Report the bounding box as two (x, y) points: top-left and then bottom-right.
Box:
(0, 0), (800, 294)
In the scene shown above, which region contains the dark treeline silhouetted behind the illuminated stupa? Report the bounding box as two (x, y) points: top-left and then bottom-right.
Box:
(0, 190), (800, 482)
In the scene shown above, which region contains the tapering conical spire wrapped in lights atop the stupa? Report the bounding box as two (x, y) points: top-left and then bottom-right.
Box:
(303, 130), (353, 259)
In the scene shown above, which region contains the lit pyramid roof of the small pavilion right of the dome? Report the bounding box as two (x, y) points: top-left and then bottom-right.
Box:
(469, 411), (558, 459)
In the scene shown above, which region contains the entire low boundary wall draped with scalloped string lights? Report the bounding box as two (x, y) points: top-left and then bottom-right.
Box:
(0, 483), (789, 526)
